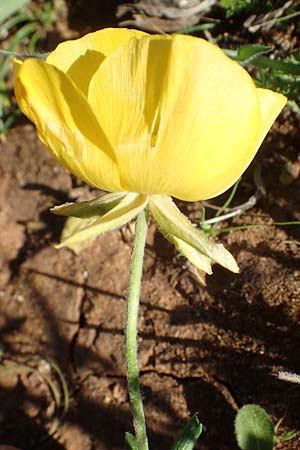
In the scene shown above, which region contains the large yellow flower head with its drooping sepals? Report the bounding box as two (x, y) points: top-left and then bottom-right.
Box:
(15, 29), (286, 273)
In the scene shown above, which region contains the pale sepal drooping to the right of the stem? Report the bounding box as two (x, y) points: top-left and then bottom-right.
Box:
(149, 195), (239, 273)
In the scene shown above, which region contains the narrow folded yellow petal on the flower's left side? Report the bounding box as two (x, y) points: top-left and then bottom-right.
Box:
(15, 59), (122, 191)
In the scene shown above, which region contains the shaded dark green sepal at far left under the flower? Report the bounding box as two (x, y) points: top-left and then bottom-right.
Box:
(50, 192), (127, 219)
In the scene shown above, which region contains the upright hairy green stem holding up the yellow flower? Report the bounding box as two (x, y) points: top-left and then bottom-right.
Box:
(125, 210), (148, 450)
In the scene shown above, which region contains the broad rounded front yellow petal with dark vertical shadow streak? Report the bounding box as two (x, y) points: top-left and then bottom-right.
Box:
(88, 35), (260, 201)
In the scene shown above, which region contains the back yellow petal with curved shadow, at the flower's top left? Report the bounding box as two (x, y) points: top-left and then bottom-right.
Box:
(46, 28), (146, 95)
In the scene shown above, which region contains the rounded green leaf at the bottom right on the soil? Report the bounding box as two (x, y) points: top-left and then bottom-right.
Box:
(234, 405), (275, 450)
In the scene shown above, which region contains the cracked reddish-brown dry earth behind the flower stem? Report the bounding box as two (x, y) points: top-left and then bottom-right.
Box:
(0, 117), (300, 450)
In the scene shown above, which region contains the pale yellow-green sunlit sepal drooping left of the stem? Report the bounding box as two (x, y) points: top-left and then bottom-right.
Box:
(56, 193), (148, 248)
